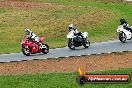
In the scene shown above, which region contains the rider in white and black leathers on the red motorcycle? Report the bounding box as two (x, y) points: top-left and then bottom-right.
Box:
(25, 29), (41, 46)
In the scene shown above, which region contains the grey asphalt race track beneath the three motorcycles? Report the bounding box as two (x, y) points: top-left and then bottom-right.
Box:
(0, 40), (132, 62)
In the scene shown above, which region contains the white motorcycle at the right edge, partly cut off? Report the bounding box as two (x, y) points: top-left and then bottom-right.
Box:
(117, 25), (132, 43)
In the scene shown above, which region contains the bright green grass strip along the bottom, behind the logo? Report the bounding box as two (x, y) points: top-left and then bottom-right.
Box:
(0, 69), (132, 88)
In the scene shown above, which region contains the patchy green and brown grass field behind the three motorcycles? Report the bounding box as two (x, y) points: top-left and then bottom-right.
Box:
(0, 0), (132, 53)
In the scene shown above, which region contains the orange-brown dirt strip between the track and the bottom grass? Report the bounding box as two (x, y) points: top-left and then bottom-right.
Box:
(0, 53), (132, 75)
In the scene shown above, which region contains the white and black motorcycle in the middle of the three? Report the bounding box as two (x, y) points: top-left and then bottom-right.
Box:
(67, 31), (90, 50)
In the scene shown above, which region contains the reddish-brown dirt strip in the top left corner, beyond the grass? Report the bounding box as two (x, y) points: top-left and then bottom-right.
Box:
(0, 0), (64, 9)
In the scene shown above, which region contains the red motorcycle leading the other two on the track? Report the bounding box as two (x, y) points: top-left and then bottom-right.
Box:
(21, 36), (49, 56)
